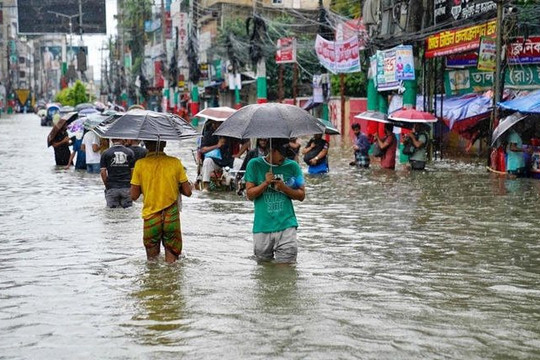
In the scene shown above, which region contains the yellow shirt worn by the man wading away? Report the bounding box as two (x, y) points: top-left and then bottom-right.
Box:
(131, 152), (188, 219)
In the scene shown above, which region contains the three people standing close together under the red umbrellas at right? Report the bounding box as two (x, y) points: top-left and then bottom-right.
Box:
(350, 123), (429, 170)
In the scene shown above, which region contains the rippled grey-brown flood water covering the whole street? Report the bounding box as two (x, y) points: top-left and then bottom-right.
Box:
(0, 114), (540, 359)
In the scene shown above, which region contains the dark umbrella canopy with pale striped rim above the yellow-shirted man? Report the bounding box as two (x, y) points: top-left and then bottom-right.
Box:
(94, 109), (199, 141)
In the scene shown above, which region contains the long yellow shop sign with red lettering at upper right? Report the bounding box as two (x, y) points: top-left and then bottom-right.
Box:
(425, 20), (497, 58)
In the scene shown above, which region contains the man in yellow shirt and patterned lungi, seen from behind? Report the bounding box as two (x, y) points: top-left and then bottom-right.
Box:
(131, 141), (191, 263)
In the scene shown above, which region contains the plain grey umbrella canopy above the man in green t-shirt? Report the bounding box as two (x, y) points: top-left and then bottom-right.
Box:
(214, 103), (325, 139)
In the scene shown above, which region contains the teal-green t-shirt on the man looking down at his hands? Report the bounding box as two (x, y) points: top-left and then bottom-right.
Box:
(244, 157), (304, 233)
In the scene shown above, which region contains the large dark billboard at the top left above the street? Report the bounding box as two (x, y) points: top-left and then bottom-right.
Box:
(17, 0), (107, 34)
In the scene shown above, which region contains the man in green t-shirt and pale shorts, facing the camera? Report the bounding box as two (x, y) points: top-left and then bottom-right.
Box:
(244, 139), (306, 263)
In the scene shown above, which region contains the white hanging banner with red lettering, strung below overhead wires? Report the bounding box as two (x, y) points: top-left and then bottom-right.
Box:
(315, 35), (360, 74)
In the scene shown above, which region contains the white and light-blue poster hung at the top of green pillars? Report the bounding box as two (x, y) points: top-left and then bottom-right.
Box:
(376, 45), (415, 91)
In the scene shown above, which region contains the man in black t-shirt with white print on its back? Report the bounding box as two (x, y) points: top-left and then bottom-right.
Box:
(100, 139), (135, 208)
